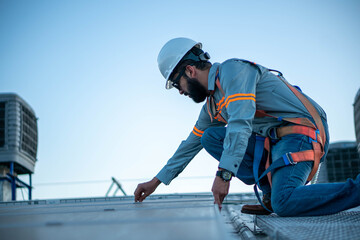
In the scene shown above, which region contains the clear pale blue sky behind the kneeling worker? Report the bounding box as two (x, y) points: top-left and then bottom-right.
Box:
(0, 0), (360, 198)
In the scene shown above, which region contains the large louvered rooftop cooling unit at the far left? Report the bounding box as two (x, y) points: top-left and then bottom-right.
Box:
(0, 93), (38, 174)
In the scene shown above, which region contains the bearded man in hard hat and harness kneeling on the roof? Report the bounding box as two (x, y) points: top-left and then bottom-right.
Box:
(134, 38), (360, 216)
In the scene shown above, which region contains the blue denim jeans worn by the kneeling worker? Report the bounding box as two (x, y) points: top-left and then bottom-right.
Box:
(201, 126), (360, 216)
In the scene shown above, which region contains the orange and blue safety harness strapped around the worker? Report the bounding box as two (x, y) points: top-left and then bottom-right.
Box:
(207, 60), (326, 212)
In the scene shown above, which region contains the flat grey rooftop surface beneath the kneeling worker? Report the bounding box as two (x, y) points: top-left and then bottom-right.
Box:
(0, 193), (360, 240)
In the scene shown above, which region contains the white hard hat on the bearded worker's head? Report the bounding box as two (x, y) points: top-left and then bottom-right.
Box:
(157, 38), (202, 89)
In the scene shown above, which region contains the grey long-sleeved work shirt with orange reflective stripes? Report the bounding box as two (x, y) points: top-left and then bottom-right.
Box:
(156, 59), (326, 185)
